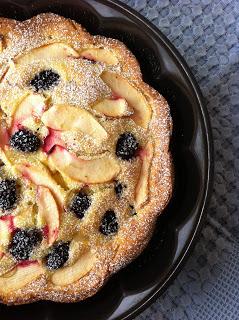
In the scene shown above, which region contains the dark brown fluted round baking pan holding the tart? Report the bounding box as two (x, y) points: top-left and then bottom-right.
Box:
(0, 0), (213, 320)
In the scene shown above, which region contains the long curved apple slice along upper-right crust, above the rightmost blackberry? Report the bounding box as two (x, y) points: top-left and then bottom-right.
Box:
(101, 71), (152, 129)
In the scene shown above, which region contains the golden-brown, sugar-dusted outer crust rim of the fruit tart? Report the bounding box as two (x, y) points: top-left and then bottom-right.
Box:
(0, 13), (173, 304)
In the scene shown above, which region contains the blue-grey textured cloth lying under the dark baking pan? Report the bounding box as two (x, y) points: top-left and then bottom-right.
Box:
(122, 0), (239, 320)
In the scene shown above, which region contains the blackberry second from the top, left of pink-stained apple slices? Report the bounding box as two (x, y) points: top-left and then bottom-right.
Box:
(10, 129), (41, 152)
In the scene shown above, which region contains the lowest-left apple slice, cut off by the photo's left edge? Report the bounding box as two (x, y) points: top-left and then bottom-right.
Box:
(0, 261), (44, 294)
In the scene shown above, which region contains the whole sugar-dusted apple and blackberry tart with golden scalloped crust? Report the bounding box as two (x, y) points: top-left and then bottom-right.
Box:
(0, 14), (172, 304)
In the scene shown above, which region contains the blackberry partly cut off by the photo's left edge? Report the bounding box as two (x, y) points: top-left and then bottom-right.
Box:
(0, 179), (17, 211)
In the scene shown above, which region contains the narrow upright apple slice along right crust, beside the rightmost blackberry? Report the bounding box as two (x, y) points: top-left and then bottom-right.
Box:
(135, 141), (154, 210)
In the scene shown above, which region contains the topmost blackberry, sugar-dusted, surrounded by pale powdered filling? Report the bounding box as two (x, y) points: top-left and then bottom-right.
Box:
(30, 69), (60, 92)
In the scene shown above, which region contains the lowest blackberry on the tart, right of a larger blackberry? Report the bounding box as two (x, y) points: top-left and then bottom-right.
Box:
(46, 242), (70, 270)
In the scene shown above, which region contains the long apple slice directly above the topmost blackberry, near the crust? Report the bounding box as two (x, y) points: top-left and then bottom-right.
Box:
(15, 42), (79, 66)
